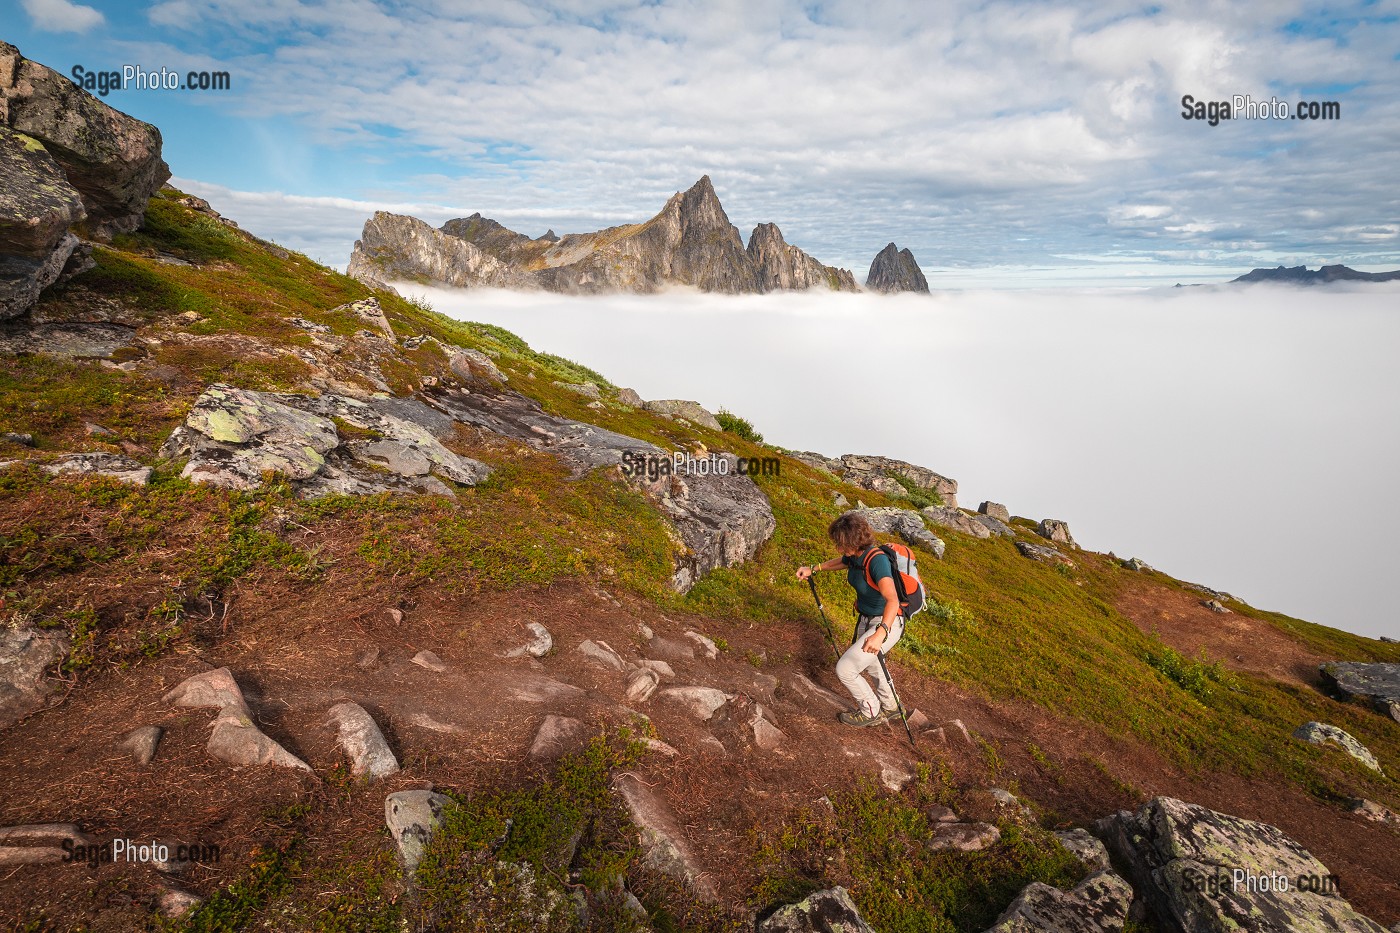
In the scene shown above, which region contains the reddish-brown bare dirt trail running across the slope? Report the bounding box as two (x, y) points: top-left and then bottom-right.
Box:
(0, 580), (1400, 929)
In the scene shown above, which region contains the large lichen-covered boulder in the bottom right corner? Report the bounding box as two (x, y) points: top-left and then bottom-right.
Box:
(1095, 797), (1385, 933)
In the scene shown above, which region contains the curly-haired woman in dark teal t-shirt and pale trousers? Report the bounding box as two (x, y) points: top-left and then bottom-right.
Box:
(797, 511), (904, 726)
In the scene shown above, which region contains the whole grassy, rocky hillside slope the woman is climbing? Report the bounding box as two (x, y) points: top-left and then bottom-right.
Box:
(0, 41), (1400, 933)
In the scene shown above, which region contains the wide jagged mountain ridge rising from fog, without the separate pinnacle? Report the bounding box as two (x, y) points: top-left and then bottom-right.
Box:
(347, 175), (858, 294)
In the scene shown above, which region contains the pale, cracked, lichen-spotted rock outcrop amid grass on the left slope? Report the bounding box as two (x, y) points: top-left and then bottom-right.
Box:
(161, 384), (490, 497)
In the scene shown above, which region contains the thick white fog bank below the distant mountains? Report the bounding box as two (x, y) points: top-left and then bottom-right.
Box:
(420, 283), (1400, 637)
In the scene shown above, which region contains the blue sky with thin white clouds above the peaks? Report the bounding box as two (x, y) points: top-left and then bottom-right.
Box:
(0, 0), (1400, 287)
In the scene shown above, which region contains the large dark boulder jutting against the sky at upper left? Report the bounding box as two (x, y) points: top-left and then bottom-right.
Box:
(0, 42), (171, 234)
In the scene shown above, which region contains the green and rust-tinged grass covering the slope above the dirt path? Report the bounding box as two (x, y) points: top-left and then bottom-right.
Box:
(0, 191), (1400, 929)
